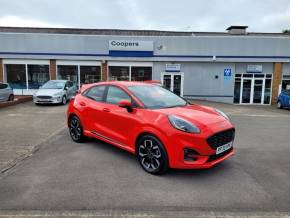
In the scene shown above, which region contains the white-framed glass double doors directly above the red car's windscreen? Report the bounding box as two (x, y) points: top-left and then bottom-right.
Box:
(161, 73), (183, 96)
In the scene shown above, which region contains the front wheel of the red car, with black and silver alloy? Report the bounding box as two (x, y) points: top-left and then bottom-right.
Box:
(136, 135), (168, 174)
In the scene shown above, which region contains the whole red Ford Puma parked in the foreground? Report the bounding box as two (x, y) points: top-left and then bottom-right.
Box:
(67, 82), (235, 174)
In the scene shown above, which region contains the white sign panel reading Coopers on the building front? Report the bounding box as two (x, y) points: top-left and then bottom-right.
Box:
(109, 40), (153, 51)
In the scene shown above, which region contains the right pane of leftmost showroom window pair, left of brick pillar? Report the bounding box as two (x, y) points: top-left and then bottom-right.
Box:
(27, 64), (49, 89)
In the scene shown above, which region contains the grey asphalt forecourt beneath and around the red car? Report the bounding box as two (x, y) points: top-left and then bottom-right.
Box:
(0, 102), (290, 215)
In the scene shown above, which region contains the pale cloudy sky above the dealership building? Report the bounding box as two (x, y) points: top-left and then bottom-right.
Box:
(0, 0), (290, 32)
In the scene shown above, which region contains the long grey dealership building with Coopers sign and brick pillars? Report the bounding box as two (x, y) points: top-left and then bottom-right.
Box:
(0, 26), (290, 104)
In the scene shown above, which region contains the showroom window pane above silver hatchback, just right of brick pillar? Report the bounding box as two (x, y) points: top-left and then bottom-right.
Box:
(57, 65), (78, 85)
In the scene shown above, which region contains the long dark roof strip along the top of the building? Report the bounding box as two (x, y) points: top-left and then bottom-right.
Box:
(0, 27), (290, 37)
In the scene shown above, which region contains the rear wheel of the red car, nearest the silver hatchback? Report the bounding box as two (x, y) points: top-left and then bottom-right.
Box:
(68, 115), (85, 143)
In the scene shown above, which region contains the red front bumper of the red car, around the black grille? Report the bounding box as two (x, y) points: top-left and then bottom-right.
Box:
(166, 121), (235, 169)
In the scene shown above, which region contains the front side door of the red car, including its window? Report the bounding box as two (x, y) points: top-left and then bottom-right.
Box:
(98, 86), (139, 146)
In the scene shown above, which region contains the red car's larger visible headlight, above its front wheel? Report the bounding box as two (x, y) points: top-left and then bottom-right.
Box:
(168, 115), (200, 133)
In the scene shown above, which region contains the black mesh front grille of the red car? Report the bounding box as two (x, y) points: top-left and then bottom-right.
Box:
(207, 129), (235, 150)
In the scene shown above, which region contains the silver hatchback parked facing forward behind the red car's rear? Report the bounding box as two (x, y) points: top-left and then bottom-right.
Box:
(33, 80), (77, 104)
